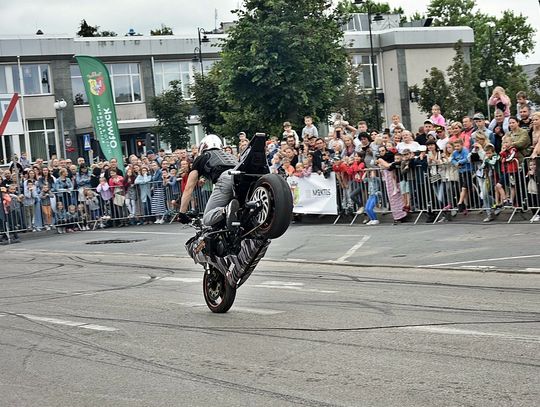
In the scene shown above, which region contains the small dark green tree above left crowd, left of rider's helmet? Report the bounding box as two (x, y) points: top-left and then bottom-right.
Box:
(150, 81), (190, 149)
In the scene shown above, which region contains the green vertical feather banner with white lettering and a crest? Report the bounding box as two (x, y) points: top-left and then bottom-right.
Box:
(75, 56), (124, 171)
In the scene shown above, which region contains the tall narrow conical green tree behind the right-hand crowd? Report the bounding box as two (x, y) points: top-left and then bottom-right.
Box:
(446, 41), (482, 120)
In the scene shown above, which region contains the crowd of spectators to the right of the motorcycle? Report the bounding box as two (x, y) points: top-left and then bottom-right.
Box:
(268, 87), (540, 225)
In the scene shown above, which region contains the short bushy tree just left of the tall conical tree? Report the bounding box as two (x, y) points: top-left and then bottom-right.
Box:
(410, 67), (452, 116)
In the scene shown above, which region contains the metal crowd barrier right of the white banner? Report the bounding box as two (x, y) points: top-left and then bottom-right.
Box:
(334, 158), (540, 225)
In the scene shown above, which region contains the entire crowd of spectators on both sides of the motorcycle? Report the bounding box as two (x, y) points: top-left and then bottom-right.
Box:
(0, 87), (540, 244)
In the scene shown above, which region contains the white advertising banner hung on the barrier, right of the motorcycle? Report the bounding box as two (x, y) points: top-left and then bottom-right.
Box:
(287, 173), (337, 215)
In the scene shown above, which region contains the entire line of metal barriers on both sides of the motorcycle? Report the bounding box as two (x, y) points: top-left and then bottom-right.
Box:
(0, 157), (540, 239)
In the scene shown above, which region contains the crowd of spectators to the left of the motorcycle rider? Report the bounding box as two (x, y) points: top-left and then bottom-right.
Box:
(0, 146), (212, 244)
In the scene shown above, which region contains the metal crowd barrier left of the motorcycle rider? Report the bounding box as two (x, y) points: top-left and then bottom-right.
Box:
(0, 181), (212, 241)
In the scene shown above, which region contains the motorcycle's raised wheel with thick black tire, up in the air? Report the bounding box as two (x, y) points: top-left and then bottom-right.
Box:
(250, 174), (293, 239)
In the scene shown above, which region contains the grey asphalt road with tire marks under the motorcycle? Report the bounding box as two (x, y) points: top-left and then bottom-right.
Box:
(0, 225), (540, 407)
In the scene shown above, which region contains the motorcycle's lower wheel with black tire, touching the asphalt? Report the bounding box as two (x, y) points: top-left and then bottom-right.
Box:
(203, 265), (236, 314)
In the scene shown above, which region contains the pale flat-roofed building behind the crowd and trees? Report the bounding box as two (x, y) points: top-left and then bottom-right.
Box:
(0, 22), (473, 165)
